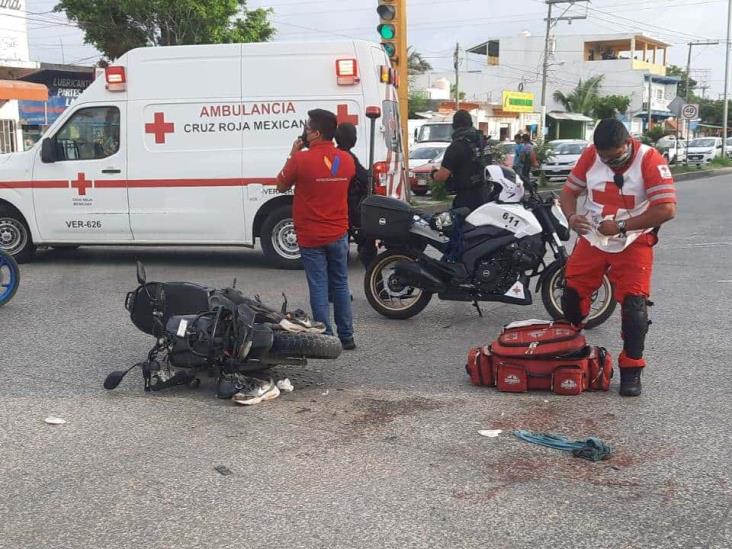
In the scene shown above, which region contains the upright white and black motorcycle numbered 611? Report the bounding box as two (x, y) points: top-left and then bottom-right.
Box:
(362, 165), (616, 328)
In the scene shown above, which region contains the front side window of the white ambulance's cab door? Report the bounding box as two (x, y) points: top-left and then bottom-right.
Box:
(54, 107), (120, 161)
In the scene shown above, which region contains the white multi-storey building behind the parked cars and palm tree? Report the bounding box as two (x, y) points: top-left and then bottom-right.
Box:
(415, 34), (679, 138)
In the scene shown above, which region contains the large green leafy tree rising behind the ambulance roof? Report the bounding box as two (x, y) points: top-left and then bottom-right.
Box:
(54, 0), (275, 60)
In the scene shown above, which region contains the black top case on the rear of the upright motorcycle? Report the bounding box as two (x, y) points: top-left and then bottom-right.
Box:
(361, 195), (414, 242)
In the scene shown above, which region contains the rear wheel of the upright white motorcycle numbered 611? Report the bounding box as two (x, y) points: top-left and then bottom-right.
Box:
(363, 250), (432, 320)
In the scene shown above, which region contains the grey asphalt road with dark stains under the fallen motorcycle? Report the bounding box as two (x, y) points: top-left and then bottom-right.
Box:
(0, 176), (732, 549)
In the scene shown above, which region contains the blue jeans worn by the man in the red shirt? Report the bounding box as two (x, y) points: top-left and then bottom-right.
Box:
(300, 234), (353, 341)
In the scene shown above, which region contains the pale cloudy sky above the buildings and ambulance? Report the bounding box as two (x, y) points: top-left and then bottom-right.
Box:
(27, 0), (732, 97)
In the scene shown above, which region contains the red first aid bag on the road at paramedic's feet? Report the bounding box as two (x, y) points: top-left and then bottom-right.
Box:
(465, 321), (613, 395)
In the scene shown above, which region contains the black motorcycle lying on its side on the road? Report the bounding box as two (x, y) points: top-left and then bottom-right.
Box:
(104, 262), (342, 398)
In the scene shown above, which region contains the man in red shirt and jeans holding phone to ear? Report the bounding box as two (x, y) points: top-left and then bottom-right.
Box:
(277, 109), (356, 350)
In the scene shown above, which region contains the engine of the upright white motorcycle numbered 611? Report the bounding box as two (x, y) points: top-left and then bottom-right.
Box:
(475, 236), (544, 295)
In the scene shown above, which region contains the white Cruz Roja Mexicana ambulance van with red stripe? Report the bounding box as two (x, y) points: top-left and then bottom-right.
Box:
(0, 40), (406, 268)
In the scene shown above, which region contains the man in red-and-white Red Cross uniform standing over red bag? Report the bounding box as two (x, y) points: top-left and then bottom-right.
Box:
(561, 119), (676, 396)
